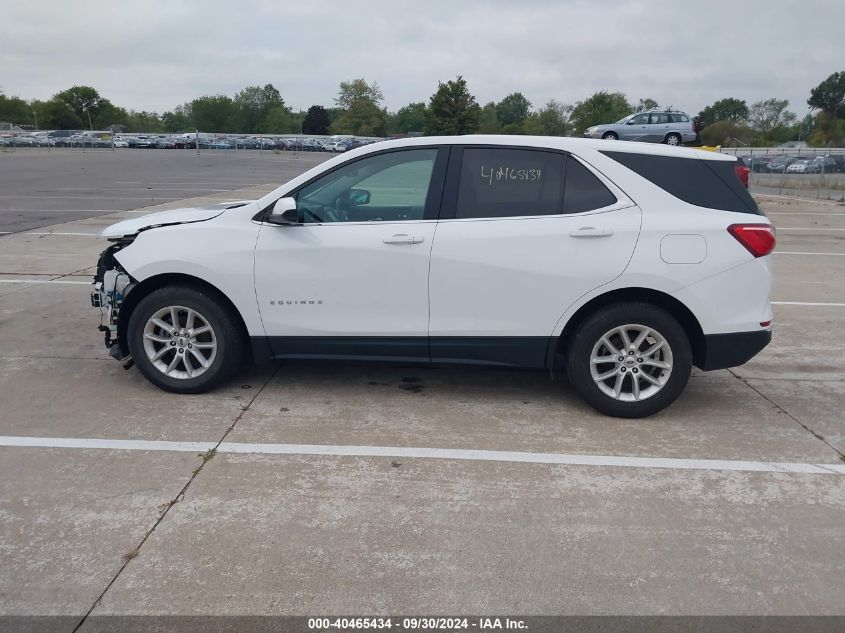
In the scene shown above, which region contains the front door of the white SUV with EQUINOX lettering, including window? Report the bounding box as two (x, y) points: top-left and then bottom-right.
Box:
(255, 148), (447, 360)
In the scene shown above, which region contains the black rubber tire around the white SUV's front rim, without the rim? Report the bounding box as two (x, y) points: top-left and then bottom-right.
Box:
(126, 285), (247, 393)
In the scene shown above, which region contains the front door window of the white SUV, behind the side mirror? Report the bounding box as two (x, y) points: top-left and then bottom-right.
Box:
(296, 149), (437, 224)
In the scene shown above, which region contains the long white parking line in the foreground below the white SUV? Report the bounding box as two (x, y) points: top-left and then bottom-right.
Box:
(0, 436), (845, 475)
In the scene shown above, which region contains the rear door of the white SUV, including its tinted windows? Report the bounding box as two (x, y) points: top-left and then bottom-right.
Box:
(429, 146), (640, 367)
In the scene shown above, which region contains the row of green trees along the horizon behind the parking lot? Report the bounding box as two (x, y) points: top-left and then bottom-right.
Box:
(0, 71), (845, 145)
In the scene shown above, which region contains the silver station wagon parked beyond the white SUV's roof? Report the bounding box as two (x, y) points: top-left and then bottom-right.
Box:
(583, 110), (696, 145)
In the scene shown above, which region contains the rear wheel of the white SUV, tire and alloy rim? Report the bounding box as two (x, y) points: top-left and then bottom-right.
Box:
(567, 303), (692, 418)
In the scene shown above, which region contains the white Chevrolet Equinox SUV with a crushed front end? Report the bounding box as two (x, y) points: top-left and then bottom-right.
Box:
(92, 136), (774, 417)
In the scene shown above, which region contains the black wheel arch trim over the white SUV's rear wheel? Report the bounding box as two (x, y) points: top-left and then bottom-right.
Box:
(549, 288), (705, 367)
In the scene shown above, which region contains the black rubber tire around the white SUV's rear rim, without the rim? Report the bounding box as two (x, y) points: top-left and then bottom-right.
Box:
(566, 302), (692, 418)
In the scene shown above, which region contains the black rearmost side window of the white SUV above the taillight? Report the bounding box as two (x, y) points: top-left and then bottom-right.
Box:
(603, 152), (762, 215)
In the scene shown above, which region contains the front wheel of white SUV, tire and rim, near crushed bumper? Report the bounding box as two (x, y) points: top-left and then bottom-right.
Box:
(127, 286), (246, 393)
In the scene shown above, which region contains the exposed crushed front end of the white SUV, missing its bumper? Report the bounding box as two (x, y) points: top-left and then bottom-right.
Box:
(91, 238), (136, 368)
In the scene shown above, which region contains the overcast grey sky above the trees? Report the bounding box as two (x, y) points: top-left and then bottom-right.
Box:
(0, 0), (845, 114)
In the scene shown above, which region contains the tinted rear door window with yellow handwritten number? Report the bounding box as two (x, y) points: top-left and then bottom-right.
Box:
(456, 148), (564, 218)
